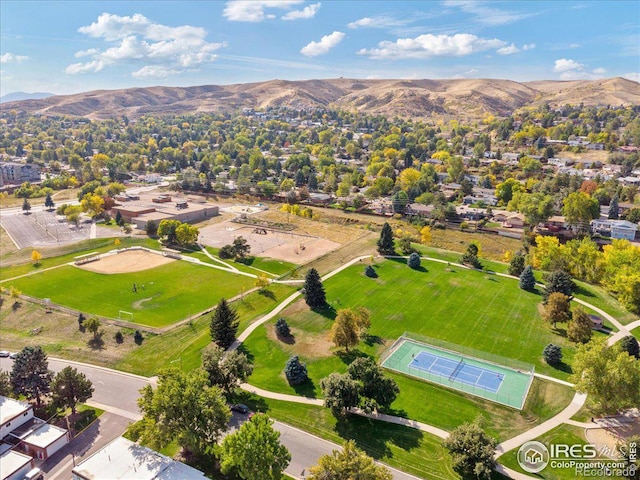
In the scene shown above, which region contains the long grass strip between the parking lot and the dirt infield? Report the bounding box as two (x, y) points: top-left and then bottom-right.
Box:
(0, 237), (160, 286)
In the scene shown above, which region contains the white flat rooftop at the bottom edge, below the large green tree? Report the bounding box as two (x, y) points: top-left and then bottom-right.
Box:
(72, 437), (207, 480)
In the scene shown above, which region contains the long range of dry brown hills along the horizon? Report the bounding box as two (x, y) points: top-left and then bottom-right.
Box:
(2, 78), (640, 120)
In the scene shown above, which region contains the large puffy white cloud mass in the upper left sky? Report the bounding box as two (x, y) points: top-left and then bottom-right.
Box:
(65, 13), (226, 78)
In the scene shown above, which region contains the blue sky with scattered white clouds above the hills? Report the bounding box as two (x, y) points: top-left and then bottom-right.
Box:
(0, 0), (640, 95)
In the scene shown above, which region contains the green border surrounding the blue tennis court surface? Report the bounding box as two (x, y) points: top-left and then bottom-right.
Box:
(380, 333), (535, 410)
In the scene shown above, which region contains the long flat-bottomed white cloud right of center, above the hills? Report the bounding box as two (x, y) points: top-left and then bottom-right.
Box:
(357, 33), (506, 60)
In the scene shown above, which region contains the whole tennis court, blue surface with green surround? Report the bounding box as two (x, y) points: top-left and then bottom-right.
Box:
(382, 336), (533, 409)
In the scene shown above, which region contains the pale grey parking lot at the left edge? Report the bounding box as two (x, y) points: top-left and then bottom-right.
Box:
(0, 211), (95, 248)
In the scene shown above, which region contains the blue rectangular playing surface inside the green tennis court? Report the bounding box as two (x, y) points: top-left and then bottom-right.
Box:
(409, 351), (504, 393)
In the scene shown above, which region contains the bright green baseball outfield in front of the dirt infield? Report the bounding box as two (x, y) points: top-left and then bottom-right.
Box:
(11, 261), (254, 327)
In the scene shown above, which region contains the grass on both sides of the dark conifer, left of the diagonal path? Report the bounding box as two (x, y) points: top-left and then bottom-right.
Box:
(113, 284), (295, 376)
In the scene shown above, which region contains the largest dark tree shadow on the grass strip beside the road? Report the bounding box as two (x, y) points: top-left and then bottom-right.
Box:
(334, 415), (424, 460)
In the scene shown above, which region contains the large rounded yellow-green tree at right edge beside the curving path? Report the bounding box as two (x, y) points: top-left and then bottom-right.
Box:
(571, 338), (640, 414)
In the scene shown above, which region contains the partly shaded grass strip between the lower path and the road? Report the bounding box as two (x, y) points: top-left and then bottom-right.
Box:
(233, 392), (460, 479)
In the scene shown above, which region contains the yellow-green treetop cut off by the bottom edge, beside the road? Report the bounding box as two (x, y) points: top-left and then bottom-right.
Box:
(306, 440), (393, 480)
